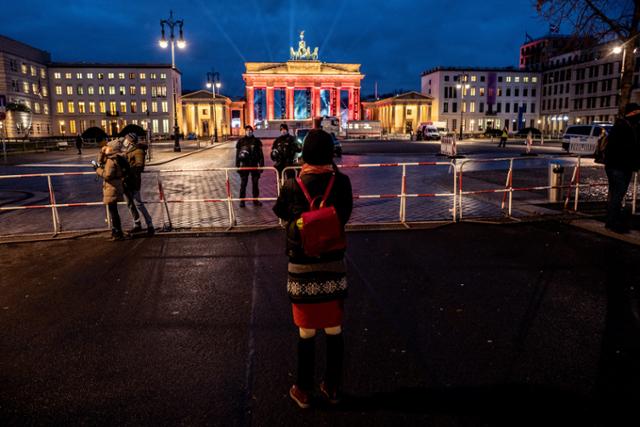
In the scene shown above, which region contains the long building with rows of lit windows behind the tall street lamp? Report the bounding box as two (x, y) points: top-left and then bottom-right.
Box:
(49, 63), (182, 136)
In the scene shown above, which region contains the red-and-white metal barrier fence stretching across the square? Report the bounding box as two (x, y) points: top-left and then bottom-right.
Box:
(0, 156), (638, 237)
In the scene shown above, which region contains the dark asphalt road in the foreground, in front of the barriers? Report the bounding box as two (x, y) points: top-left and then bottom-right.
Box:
(0, 223), (640, 426)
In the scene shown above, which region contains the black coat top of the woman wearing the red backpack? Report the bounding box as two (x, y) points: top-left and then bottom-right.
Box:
(273, 172), (353, 264)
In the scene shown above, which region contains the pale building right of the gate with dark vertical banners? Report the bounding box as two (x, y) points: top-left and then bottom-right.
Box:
(421, 67), (541, 134)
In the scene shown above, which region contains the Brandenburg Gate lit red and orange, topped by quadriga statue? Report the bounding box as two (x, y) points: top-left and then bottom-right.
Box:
(242, 31), (364, 128)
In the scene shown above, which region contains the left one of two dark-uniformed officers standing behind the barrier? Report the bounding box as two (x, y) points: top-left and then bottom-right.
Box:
(236, 125), (264, 208)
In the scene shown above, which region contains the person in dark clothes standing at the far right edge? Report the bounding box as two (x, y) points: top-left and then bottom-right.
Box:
(604, 103), (640, 233)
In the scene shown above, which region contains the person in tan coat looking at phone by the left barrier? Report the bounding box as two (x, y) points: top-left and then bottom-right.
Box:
(94, 145), (126, 240)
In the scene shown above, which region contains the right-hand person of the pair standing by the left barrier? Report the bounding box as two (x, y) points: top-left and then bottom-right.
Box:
(122, 133), (155, 236)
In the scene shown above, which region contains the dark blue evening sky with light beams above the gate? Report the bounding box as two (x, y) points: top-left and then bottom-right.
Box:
(0, 0), (548, 95)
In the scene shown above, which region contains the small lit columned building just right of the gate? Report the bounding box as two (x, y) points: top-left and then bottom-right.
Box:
(362, 92), (432, 133)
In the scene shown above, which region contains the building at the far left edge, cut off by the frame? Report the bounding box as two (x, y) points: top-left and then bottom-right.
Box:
(0, 36), (52, 138)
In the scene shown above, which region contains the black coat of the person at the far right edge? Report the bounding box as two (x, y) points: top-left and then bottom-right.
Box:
(604, 119), (640, 171)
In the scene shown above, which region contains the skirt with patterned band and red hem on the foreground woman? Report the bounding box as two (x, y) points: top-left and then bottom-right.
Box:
(287, 260), (347, 329)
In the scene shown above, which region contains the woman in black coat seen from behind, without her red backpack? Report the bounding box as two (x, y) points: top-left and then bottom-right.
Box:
(273, 129), (353, 408)
